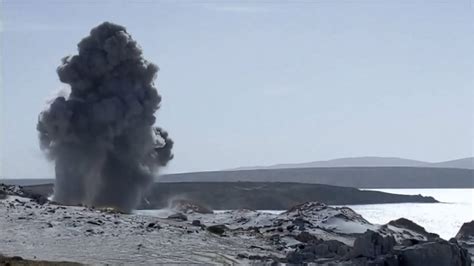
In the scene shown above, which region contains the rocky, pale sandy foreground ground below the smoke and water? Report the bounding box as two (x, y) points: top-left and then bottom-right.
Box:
(0, 186), (474, 265)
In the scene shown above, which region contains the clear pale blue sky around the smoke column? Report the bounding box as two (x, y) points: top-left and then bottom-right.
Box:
(0, 0), (474, 178)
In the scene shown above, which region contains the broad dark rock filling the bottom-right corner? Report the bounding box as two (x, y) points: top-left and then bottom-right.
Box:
(394, 239), (471, 266)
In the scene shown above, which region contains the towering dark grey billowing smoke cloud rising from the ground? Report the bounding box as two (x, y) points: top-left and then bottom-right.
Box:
(37, 22), (173, 211)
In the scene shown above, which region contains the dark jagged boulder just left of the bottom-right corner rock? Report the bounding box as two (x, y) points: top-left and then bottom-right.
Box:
(351, 230), (396, 258)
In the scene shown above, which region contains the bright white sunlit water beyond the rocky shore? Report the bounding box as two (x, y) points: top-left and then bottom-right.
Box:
(137, 189), (474, 240)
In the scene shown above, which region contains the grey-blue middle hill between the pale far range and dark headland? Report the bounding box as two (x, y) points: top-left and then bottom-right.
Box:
(159, 167), (474, 188)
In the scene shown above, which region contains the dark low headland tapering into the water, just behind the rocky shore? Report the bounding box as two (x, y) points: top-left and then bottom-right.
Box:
(25, 182), (437, 210)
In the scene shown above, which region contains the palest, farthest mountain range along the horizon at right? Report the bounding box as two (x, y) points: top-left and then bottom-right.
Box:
(228, 157), (474, 171)
